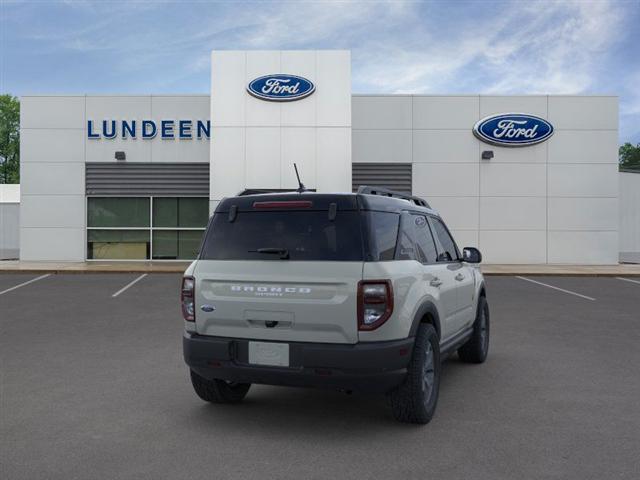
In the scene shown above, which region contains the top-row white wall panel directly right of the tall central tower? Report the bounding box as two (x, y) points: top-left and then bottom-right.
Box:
(351, 95), (412, 130)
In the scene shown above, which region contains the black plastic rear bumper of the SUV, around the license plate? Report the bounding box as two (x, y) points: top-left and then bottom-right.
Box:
(182, 332), (414, 392)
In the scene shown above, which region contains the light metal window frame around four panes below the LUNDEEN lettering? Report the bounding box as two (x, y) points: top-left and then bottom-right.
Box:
(84, 195), (212, 263)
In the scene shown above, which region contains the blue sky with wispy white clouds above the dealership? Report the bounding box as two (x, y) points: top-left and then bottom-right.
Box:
(0, 0), (640, 143)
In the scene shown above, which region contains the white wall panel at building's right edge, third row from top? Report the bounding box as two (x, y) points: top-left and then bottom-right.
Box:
(549, 164), (618, 198)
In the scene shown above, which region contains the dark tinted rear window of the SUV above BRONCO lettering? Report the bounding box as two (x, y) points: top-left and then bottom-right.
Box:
(200, 211), (363, 261)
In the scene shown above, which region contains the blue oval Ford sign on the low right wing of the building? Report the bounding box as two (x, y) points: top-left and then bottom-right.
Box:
(473, 113), (553, 147)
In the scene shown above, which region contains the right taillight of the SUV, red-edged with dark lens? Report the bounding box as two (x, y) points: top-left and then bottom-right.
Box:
(358, 280), (393, 330)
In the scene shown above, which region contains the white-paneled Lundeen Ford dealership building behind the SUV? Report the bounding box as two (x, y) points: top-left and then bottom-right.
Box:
(20, 50), (620, 264)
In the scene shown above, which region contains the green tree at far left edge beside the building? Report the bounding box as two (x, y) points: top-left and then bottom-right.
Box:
(0, 95), (20, 183)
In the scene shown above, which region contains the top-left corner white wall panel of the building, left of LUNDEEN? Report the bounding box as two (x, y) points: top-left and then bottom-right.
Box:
(20, 95), (85, 128)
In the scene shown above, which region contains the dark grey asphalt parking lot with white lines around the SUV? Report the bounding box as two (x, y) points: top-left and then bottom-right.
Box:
(0, 274), (640, 480)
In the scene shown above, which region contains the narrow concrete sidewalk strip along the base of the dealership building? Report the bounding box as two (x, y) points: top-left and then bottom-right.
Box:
(0, 260), (640, 277)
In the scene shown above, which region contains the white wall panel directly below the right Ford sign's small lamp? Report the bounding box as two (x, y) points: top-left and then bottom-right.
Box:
(480, 162), (547, 197)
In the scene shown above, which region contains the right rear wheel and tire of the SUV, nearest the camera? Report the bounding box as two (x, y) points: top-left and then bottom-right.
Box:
(389, 323), (442, 425)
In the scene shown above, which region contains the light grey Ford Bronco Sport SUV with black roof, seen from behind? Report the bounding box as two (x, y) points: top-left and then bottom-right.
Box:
(181, 187), (489, 423)
